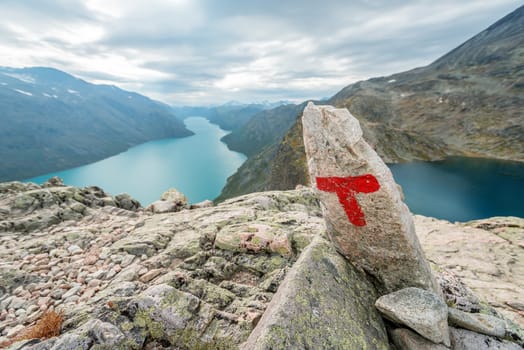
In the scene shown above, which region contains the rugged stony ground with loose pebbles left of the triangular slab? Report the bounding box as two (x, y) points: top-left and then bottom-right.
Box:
(0, 182), (323, 349)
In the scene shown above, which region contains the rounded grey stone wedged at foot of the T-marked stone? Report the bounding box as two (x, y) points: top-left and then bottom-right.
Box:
(375, 287), (450, 346)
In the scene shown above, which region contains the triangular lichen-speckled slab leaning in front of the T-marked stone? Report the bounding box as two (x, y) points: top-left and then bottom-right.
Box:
(241, 236), (389, 350)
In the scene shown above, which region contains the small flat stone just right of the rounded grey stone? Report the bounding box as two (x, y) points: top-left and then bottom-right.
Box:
(448, 308), (506, 337)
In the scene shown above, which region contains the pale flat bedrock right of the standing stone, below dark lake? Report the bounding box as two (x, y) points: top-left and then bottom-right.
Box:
(414, 215), (524, 327)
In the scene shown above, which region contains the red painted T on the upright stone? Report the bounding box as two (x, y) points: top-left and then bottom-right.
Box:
(317, 174), (380, 226)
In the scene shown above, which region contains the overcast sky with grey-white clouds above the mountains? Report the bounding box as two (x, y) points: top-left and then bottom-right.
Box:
(0, 0), (522, 105)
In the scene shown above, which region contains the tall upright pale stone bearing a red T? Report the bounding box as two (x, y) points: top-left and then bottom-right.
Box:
(302, 103), (440, 293)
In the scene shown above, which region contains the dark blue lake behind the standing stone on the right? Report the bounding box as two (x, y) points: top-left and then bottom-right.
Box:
(390, 157), (524, 221)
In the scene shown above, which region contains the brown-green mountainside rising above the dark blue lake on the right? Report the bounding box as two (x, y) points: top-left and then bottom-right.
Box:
(329, 6), (524, 161)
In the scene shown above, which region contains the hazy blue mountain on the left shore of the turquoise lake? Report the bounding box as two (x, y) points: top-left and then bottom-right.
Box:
(0, 67), (192, 181)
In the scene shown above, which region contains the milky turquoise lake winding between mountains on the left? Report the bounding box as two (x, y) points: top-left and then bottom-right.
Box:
(26, 117), (246, 205)
